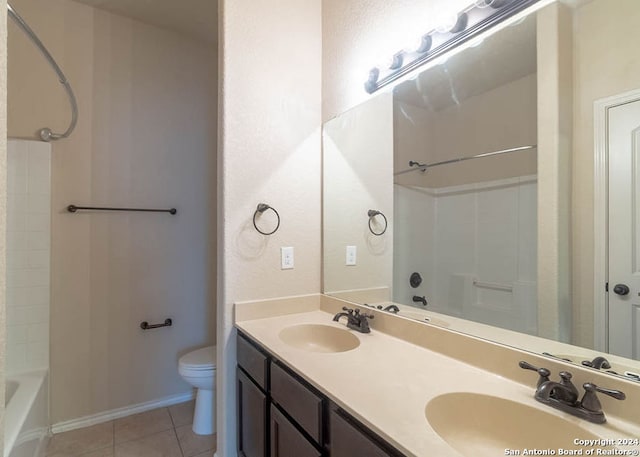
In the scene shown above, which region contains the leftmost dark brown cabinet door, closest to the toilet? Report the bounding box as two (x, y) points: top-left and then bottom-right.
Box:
(236, 368), (267, 457)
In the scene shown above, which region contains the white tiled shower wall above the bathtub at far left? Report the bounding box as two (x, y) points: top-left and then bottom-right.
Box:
(7, 140), (51, 374)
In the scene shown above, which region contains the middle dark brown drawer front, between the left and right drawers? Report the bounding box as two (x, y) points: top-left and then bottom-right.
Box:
(271, 363), (323, 444)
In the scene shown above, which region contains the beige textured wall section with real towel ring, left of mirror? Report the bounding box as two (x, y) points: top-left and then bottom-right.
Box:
(217, 0), (322, 456)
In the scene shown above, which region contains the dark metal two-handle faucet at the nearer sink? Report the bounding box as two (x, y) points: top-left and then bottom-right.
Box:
(520, 361), (627, 424)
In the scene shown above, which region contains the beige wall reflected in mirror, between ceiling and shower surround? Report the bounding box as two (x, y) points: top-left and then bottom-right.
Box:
(394, 74), (537, 188)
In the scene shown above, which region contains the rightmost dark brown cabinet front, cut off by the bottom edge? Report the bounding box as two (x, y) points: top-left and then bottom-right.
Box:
(329, 410), (402, 457)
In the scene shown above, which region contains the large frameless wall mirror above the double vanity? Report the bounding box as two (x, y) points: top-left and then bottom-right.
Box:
(323, 0), (640, 379)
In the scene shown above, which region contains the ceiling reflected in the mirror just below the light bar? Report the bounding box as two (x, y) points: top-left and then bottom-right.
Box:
(394, 16), (536, 111)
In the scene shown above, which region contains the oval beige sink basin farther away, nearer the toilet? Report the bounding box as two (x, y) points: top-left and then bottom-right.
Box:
(278, 324), (360, 352)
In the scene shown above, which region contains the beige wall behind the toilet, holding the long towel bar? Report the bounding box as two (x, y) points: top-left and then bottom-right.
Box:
(3, 0), (217, 423)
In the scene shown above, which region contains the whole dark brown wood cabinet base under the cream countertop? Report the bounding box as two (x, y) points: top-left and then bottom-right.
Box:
(237, 333), (402, 457)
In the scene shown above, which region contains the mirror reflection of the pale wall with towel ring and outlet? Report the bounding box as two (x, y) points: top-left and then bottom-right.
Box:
(322, 93), (394, 294)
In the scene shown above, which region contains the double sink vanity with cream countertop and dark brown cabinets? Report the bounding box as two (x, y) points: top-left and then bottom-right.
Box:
(235, 295), (640, 457)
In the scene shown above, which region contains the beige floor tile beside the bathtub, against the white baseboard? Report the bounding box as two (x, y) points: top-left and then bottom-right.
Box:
(47, 421), (113, 457)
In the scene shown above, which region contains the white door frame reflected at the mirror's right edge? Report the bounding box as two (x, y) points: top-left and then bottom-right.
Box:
(593, 89), (640, 352)
